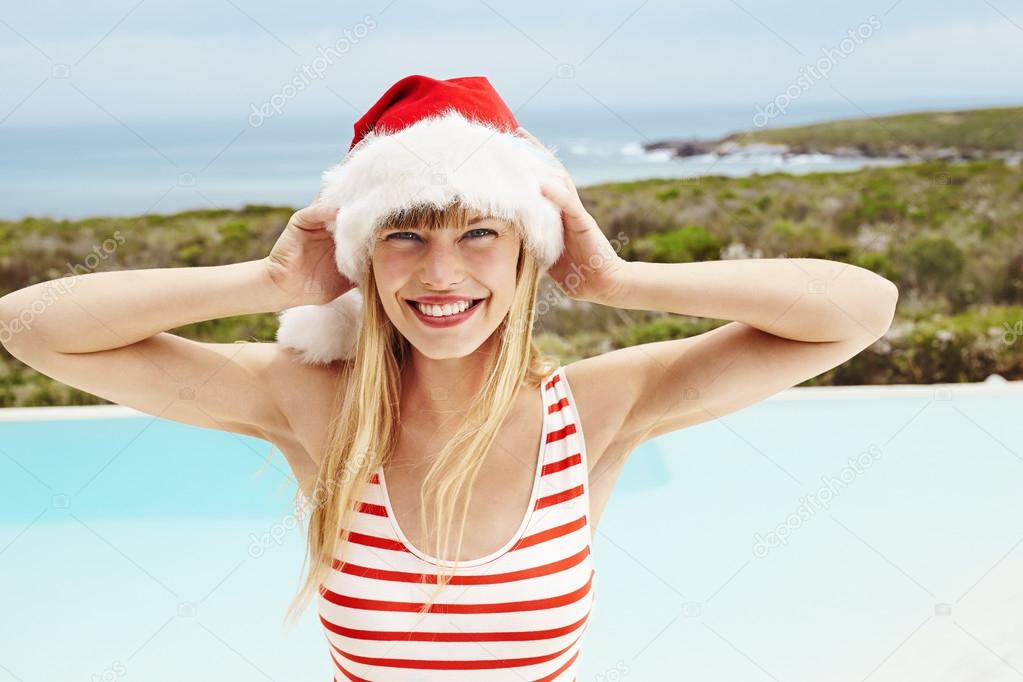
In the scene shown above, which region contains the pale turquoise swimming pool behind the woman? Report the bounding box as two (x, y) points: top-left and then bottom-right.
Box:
(0, 382), (1023, 682)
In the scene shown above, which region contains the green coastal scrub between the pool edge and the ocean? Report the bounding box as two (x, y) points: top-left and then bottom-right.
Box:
(0, 160), (1023, 406)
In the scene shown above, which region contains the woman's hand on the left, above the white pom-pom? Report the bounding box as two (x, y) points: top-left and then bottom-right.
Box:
(264, 202), (356, 308)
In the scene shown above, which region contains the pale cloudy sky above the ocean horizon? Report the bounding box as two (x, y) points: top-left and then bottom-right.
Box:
(0, 0), (1023, 129)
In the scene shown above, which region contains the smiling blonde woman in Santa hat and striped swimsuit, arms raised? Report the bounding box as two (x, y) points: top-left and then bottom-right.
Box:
(0, 77), (897, 680)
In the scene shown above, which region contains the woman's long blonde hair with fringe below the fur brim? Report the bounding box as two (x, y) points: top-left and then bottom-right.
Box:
(285, 202), (560, 624)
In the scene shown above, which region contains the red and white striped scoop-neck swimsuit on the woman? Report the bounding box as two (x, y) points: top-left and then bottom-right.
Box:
(318, 365), (596, 682)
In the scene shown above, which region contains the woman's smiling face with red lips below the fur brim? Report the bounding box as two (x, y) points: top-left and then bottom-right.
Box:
(371, 218), (522, 360)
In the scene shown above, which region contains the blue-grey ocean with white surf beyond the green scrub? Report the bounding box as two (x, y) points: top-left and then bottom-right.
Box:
(0, 102), (937, 220)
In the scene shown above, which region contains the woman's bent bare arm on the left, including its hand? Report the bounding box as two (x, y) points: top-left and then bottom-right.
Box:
(0, 208), (349, 447)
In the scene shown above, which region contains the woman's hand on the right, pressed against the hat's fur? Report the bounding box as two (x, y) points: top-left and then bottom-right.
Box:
(518, 128), (627, 303)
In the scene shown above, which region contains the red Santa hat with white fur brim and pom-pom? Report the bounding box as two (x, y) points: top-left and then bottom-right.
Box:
(276, 76), (564, 363)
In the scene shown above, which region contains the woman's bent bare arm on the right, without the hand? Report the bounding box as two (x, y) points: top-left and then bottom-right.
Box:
(575, 259), (898, 445)
